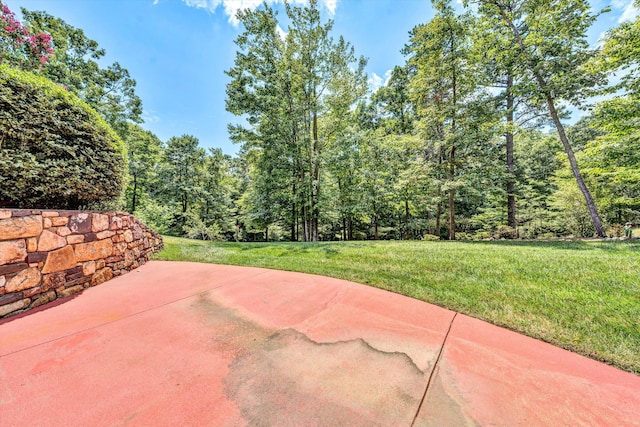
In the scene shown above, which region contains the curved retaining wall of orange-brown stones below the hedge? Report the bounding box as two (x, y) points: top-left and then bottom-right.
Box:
(0, 209), (163, 318)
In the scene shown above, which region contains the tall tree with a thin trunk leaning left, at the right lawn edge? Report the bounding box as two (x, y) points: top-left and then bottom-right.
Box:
(475, 0), (605, 237)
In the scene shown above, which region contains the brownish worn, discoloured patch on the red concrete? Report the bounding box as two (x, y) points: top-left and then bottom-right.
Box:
(194, 295), (428, 426)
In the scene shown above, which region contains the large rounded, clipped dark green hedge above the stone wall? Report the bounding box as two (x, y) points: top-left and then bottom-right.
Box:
(0, 65), (126, 209)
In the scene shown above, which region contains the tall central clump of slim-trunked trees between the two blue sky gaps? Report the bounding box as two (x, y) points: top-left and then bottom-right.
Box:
(227, 0), (365, 241)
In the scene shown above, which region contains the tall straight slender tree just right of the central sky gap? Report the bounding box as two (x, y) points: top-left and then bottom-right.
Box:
(405, 1), (486, 240)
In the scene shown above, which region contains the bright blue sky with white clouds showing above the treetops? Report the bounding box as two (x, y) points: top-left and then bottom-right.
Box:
(3, 0), (637, 154)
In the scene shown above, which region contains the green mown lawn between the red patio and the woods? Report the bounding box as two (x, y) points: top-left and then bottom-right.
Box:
(154, 237), (640, 374)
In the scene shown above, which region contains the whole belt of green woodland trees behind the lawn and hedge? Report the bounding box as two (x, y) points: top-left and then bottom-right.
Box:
(0, 0), (640, 241)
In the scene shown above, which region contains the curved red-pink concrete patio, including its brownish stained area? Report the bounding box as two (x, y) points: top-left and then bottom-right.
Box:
(0, 261), (640, 426)
